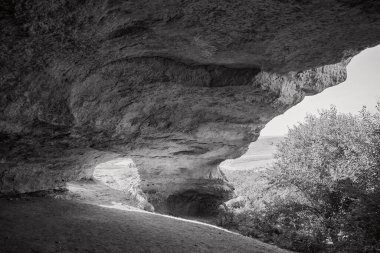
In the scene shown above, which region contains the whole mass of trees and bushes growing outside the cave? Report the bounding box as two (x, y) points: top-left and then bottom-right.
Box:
(219, 106), (380, 252)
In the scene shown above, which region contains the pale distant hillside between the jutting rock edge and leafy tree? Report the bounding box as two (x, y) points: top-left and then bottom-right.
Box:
(220, 136), (284, 170)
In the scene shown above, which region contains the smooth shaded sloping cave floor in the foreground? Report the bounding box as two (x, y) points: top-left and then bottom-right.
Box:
(0, 197), (287, 253)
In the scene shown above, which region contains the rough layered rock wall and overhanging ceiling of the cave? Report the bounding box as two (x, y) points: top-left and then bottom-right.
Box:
(0, 0), (380, 213)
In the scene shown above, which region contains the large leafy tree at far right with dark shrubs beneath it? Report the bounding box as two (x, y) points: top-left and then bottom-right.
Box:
(268, 106), (380, 252)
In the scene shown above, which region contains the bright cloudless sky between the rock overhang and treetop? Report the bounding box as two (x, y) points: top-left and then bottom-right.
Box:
(260, 45), (380, 136)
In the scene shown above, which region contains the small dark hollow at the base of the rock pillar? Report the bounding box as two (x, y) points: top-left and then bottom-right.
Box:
(167, 190), (225, 217)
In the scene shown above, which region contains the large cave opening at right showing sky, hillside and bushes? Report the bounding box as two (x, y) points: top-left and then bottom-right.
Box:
(214, 46), (380, 252)
